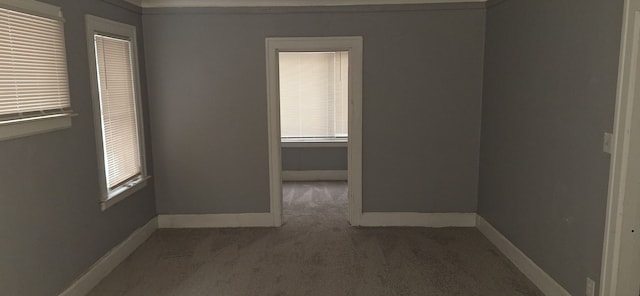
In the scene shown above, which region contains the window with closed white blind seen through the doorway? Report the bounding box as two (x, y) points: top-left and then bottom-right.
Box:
(279, 51), (349, 140)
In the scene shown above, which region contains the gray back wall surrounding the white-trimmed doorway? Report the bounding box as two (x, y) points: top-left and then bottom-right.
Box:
(143, 5), (485, 214)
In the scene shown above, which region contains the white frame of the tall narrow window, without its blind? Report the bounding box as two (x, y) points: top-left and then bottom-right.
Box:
(86, 15), (150, 211)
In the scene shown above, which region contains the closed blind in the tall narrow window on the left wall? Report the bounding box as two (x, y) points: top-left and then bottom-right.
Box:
(94, 35), (141, 190)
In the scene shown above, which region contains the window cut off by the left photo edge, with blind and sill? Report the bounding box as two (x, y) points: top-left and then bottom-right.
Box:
(0, 0), (72, 139)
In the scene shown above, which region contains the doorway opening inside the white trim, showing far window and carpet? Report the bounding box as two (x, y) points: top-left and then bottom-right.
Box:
(278, 51), (349, 225)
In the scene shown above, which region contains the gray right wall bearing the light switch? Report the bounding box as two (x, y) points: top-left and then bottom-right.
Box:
(478, 0), (623, 295)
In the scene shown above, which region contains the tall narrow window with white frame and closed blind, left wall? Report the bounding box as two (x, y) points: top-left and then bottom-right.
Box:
(87, 16), (147, 209)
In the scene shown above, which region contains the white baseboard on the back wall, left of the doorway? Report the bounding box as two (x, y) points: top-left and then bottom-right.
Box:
(158, 213), (274, 228)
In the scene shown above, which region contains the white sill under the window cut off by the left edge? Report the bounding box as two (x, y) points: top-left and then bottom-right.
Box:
(0, 114), (75, 141)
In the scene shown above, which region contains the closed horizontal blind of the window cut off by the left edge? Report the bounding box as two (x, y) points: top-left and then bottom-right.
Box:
(0, 8), (70, 121)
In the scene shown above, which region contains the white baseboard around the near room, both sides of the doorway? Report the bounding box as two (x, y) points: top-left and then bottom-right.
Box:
(55, 212), (571, 296)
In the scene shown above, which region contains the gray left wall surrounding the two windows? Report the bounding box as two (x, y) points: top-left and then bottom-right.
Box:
(0, 0), (155, 295)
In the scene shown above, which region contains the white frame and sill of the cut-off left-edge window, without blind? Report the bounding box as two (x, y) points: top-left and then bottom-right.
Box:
(0, 0), (75, 141)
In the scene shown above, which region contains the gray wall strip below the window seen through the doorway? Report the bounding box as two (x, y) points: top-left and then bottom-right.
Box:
(282, 147), (348, 171)
